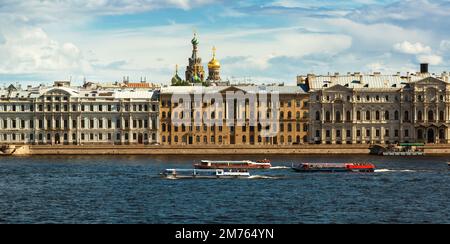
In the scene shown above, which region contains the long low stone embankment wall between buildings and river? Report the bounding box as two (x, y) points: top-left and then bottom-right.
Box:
(2, 145), (450, 156)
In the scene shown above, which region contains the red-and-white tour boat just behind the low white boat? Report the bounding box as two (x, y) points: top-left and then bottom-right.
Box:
(194, 159), (272, 169)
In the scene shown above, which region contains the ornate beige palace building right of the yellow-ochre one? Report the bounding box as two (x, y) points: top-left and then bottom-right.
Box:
(298, 65), (450, 144)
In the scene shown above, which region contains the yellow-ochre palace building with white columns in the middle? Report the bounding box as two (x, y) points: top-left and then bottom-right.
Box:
(159, 85), (308, 145)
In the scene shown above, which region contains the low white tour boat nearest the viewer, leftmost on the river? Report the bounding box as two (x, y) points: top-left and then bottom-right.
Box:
(161, 169), (250, 179)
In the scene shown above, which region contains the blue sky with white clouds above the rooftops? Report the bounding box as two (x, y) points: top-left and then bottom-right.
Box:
(0, 0), (450, 86)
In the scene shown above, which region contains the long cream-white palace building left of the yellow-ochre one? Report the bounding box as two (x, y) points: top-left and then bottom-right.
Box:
(0, 82), (159, 145)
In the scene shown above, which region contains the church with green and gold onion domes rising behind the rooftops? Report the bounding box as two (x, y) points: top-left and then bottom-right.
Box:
(171, 33), (229, 86)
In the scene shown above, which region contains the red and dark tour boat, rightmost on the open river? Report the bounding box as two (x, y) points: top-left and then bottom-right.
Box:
(292, 163), (375, 172)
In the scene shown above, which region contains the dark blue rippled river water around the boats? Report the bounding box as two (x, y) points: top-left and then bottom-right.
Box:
(0, 156), (450, 224)
